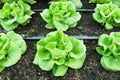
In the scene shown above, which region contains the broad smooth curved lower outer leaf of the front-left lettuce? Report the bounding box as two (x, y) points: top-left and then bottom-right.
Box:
(0, 42), (21, 67)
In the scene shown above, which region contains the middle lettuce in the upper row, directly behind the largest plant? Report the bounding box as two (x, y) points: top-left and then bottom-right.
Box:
(40, 1), (81, 31)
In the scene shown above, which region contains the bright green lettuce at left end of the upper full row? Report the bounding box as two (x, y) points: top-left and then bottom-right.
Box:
(0, 0), (34, 31)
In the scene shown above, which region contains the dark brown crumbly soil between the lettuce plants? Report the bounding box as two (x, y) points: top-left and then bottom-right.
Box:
(0, 0), (120, 80)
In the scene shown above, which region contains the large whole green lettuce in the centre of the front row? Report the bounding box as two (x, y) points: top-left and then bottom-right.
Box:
(33, 31), (86, 76)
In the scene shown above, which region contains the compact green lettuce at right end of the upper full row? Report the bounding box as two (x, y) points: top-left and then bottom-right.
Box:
(93, 3), (120, 30)
